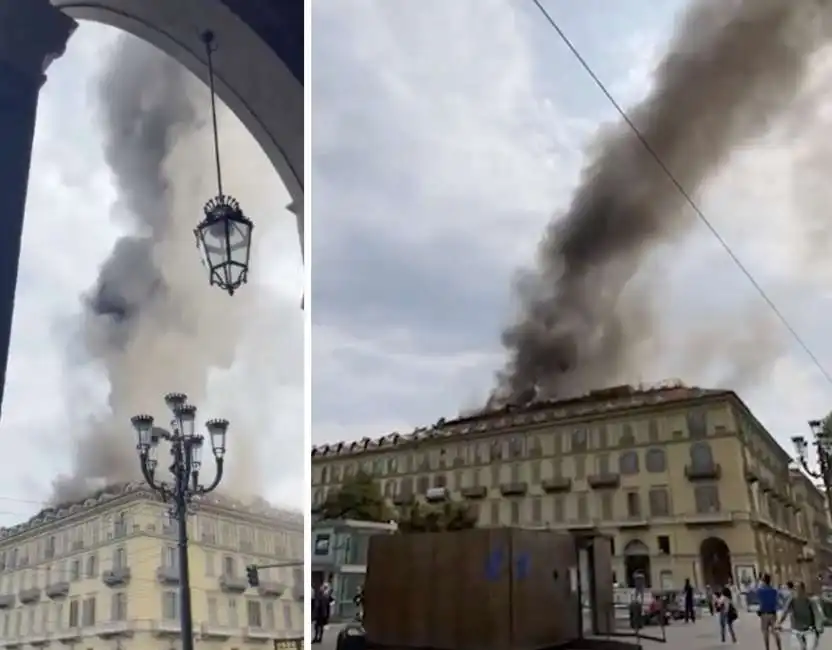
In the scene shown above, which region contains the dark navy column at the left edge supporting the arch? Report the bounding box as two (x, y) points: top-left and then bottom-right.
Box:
(0, 0), (77, 414)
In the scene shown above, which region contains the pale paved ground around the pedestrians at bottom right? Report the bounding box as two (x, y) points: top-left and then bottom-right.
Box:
(320, 612), (832, 650)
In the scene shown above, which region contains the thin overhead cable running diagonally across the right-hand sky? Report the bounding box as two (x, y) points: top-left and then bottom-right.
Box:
(532, 0), (832, 386)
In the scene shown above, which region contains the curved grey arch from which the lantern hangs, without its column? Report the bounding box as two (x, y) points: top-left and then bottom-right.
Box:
(51, 0), (304, 246)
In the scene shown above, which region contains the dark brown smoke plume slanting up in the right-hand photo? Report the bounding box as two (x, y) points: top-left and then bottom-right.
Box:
(491, 0), (830, 405)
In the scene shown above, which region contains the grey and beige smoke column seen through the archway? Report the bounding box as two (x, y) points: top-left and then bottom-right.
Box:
(53, 37), (256, 501)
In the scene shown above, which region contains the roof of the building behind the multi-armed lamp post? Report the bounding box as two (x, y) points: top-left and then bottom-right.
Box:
(0, 481), (303, 541)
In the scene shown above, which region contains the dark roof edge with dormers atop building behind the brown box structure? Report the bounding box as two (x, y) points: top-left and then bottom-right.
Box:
(312, 381), (741, 462)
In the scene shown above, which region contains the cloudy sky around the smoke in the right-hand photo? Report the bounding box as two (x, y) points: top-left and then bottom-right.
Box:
(312, 0), (832, 466)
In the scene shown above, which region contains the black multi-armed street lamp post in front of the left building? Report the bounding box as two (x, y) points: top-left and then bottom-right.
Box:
(130, 393), (228, 650)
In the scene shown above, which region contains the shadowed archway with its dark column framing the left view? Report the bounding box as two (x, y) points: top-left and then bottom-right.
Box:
(0, 0), (304, 416)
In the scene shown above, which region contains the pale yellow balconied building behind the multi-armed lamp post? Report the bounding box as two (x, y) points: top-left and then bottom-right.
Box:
(0, 483), (305, 650)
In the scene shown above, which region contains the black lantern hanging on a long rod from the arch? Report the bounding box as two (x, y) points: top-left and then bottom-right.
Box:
(194, 31), (254, 296)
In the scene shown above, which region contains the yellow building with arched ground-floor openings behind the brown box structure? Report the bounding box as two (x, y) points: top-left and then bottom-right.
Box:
(312, 383), (830, 588)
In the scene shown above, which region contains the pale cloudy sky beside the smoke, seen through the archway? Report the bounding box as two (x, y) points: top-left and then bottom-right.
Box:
(0, 23), (306, 525)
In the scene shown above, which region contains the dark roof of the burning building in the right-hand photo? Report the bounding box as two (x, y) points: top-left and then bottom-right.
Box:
(312, 379), (736, 458)
